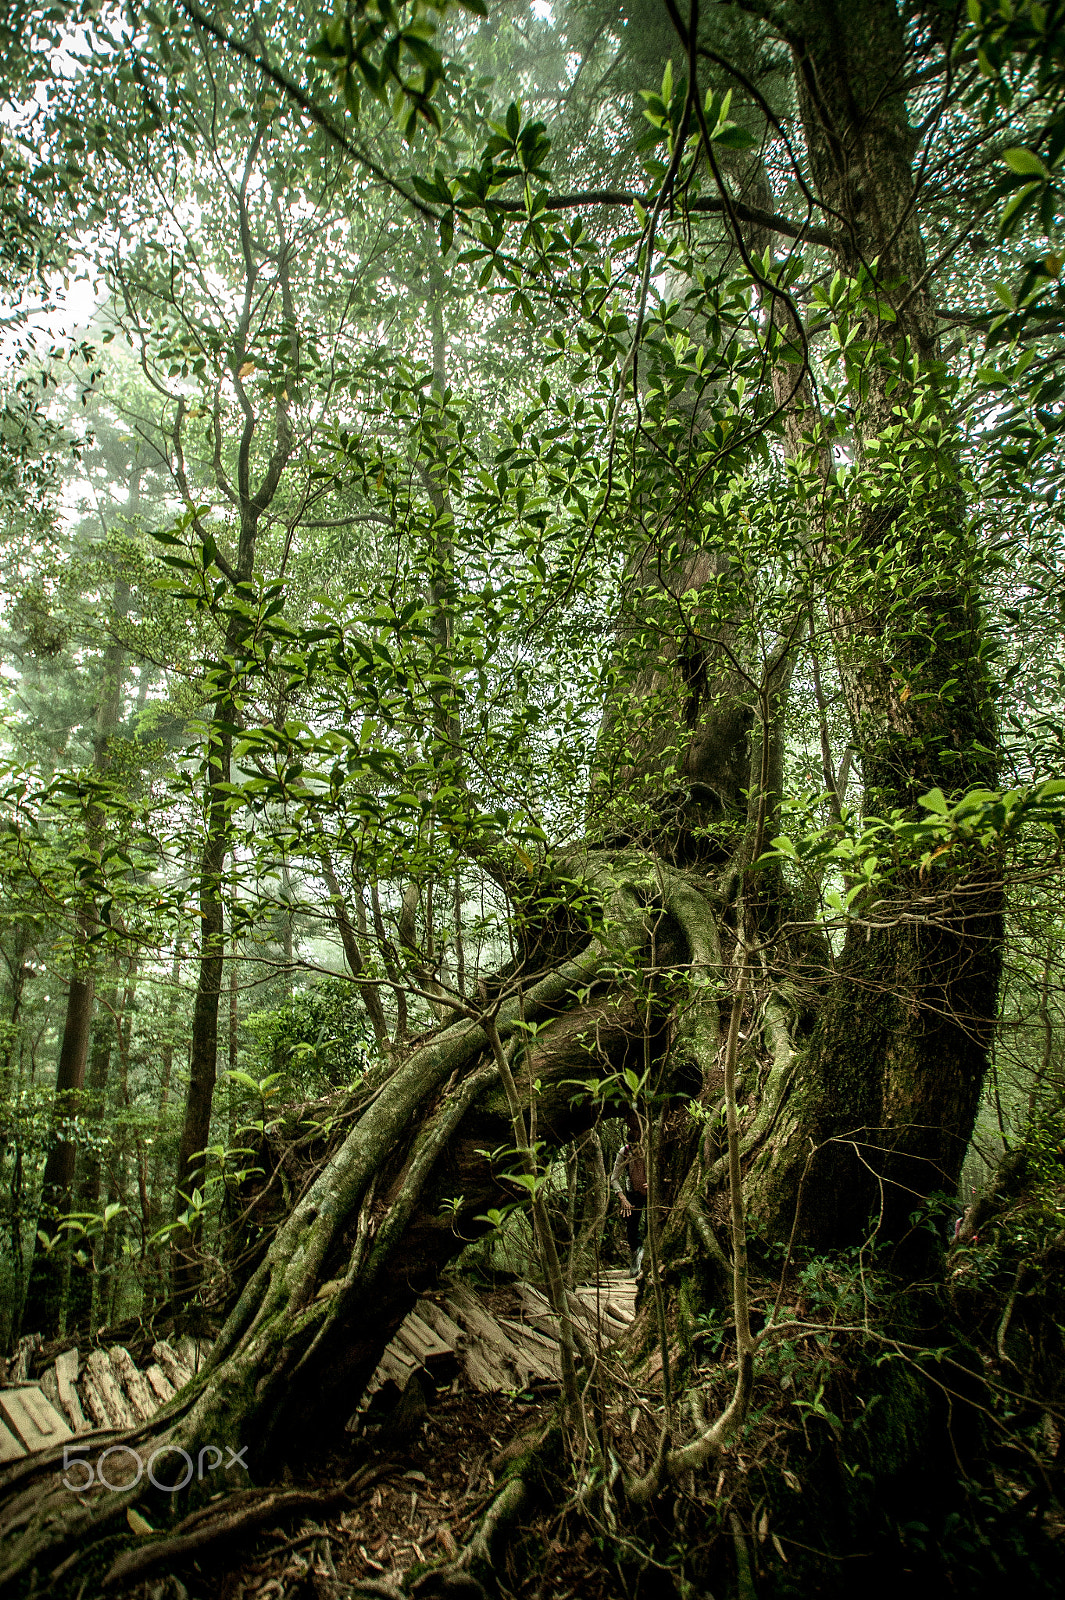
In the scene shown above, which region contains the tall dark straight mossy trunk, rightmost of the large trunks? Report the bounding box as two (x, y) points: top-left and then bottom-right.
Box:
(741, 0), (1003, 1245)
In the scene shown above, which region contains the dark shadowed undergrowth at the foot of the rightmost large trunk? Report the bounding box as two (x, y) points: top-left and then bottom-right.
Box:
(600, 1228), (1065, 1600)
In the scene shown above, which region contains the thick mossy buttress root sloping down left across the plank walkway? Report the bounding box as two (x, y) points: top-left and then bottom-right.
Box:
(0, 853), (857, 1584)
